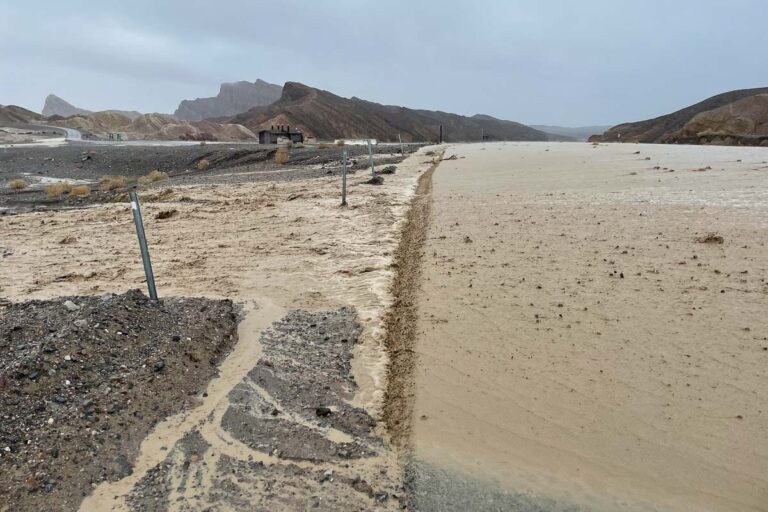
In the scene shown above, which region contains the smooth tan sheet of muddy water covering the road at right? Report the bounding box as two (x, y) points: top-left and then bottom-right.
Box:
(408, 143), (768, 511)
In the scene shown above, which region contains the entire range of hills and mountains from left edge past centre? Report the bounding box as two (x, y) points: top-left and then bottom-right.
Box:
(0, 80), (602, 142)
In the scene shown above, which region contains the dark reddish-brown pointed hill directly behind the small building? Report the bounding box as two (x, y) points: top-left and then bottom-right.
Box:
(231, 82), (553, 142)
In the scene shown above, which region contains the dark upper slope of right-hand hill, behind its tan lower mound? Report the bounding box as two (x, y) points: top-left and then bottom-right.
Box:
(589, 87), (768, 143)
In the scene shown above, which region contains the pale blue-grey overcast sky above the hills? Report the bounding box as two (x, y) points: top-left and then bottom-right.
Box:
(0, 0), (768, 126)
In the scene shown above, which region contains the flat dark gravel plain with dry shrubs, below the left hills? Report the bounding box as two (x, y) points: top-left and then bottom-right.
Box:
(0, 143), (420, 215)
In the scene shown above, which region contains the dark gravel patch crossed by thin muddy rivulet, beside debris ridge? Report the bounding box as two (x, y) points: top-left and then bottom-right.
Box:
(222, 308), (381, 462)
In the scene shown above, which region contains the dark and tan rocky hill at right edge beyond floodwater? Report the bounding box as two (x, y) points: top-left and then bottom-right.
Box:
(590, 87), (768, 145)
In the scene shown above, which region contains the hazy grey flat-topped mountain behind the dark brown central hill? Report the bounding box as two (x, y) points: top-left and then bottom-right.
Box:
(174, 80), (283, 121)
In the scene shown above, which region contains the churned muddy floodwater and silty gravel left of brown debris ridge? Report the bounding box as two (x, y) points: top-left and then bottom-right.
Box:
(0, 146), (432, 511)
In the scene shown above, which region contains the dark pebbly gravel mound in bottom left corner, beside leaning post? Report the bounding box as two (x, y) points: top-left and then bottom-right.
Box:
(0, 290), (236, 511)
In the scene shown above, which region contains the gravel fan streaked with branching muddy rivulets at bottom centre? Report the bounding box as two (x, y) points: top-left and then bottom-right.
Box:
(127, 308), (397, 512)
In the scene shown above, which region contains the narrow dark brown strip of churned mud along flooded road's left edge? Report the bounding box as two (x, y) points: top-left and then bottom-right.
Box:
(382, 153), (442, 450)
